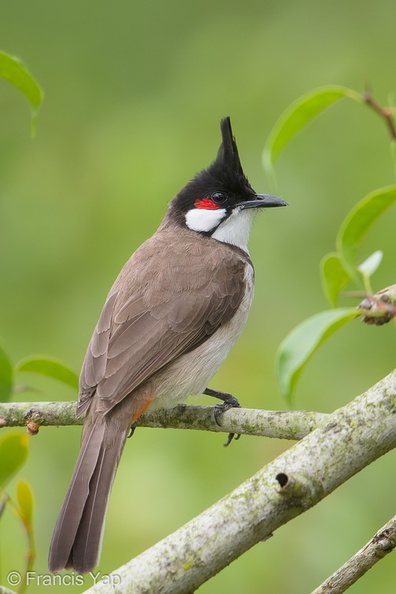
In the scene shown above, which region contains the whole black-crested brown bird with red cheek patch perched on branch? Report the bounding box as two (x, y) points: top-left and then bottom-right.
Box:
(49, 117), (287, 573)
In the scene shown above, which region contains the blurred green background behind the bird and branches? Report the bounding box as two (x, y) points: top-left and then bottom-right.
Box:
(0, 0), (396, 594)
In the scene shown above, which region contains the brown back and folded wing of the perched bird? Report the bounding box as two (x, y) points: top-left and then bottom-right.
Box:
(78, 233), (251, 414)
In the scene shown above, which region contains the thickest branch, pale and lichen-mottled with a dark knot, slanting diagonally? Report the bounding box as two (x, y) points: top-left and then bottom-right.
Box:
(79, 372), (396, 594)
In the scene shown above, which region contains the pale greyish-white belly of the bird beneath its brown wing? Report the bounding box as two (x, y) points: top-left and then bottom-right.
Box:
(151, 263), (254, 408)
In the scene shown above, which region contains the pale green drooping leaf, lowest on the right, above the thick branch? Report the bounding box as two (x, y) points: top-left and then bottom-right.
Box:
(276, 307), (358, 402)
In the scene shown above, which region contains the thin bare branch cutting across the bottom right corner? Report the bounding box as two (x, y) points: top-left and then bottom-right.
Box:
(312, 516), (396, 594)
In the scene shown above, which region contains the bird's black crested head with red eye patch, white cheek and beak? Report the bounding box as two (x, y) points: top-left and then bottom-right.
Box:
(162, 117), (286, 243)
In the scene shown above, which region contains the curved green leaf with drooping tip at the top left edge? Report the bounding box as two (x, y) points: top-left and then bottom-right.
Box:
(0, 52), (44, 136)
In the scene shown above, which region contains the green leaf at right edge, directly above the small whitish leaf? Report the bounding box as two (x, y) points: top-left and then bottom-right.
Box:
(336, 186), (396, 276)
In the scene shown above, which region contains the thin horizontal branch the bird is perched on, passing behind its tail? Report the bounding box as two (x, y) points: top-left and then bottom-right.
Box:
(0, 402), (327, 440)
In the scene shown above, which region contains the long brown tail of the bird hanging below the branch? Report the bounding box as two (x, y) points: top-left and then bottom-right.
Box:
(48, 419), (128, 573)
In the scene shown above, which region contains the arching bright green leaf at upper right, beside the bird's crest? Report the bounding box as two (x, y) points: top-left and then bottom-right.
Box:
(263, 85), (363, 173)
